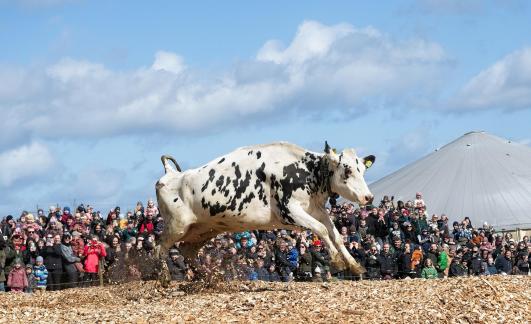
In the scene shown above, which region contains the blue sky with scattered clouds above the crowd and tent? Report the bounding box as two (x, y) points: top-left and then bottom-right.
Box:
(0, 0), (531, 216)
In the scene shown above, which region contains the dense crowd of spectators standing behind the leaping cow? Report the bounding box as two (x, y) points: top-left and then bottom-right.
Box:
(0, 193), (531, 292)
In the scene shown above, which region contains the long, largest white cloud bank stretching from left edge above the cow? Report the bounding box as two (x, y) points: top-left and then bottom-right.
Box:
(0, 21), (454, 147)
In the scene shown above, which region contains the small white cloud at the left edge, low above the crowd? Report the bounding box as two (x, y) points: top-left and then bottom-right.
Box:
(0, 142), (55, 187)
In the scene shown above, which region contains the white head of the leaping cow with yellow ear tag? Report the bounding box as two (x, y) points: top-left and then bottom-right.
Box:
(325, 143), (376, 205)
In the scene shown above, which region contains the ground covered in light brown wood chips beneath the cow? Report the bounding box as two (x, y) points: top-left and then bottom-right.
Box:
(0, 276), (531, 323)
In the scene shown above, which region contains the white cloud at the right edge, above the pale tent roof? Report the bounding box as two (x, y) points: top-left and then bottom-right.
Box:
(450, 48), (531, 110)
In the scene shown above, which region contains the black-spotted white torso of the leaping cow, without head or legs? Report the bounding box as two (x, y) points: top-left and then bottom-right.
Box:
(181, 142), (318, 222)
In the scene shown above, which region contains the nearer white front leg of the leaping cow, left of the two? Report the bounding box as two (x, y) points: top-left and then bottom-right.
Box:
(288, 203), (342, 266)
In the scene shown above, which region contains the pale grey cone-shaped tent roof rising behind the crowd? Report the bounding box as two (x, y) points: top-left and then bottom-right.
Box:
(369, 132), (531, 229)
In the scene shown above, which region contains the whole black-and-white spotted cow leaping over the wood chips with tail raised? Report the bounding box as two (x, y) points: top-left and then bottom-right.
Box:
(156, 142), (375, 273)
